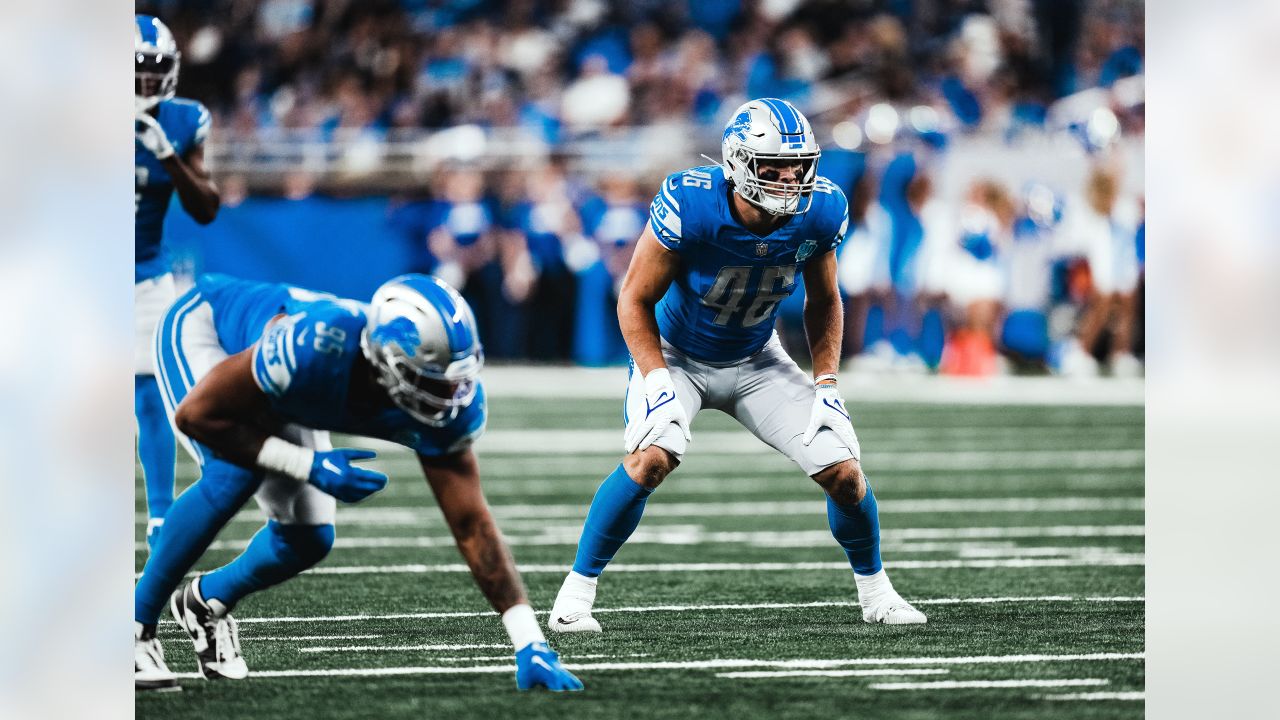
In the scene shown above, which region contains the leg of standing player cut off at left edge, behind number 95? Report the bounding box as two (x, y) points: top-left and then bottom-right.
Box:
(133, 273), (175, 547)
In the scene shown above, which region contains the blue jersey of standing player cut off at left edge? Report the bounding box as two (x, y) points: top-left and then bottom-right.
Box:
(133, 97), (209, 282)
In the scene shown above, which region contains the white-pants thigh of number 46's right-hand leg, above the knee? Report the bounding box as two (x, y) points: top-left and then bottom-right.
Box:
(732, 337), (855, 477)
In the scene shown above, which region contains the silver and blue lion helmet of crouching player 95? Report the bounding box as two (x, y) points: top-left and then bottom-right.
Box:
(360, 274), (484, 425)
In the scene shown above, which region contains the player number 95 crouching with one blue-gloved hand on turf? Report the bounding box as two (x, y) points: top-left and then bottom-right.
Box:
(134, 275), (582, 691)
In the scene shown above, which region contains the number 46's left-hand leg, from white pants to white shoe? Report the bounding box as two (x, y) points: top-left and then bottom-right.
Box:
(547, 350), (707, 633)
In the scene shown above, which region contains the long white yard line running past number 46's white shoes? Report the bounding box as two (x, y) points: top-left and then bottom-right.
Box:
(296, 552), (1146, 575)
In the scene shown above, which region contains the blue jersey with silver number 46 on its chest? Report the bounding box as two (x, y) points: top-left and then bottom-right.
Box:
(649, 165), (849, 364)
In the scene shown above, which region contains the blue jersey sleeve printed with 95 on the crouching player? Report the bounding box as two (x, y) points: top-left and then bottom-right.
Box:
(253, 301), (365, 405)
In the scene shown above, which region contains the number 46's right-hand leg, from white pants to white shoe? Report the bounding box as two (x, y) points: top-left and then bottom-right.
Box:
(731, 336), (925, 625)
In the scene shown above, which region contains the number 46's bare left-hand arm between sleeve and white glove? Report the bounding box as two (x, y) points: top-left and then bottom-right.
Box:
(618, 224), (680, 375)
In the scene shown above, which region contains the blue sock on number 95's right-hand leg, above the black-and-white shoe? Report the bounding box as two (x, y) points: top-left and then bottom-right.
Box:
(200, 520), (334, 607)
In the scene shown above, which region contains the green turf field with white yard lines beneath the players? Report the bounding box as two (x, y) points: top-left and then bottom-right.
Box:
(137, 397), (1144, 720)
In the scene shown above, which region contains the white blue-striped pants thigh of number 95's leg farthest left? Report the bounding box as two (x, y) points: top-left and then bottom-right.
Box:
(152, 290), (228, 464)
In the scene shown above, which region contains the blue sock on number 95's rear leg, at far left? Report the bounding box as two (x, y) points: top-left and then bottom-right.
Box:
(133, 460), (259, 625)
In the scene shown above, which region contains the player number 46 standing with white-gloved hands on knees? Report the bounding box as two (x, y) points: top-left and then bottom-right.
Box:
(548, 97), (925, 632)
